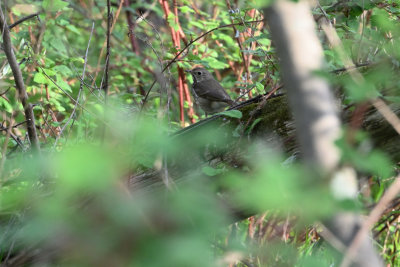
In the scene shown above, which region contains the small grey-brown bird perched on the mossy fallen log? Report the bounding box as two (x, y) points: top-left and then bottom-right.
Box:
(186, 68), (235, 115)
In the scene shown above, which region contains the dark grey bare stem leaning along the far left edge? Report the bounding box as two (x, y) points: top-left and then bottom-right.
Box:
(0, 7), (40, 152)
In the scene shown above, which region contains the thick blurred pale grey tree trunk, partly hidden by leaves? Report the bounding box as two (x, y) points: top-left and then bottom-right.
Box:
(266, 0), (384, 267)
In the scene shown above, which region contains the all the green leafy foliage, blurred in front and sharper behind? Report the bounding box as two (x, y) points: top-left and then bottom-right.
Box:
(0, 0), (400, 266)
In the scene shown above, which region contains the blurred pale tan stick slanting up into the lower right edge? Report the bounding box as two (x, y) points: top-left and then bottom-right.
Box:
(340, 175), (400, 267)
